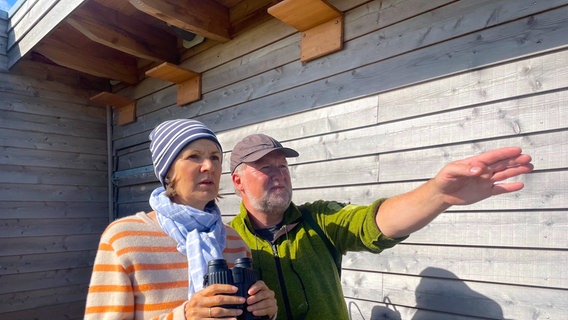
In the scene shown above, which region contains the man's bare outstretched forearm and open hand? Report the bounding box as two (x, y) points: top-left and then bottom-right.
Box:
(376, 147), (533, 238)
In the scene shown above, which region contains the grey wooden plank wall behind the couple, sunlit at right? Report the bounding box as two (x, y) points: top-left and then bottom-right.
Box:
(28, 0), (568, 319)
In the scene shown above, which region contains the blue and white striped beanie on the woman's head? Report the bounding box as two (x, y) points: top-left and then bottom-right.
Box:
(150, 119), (223, 187)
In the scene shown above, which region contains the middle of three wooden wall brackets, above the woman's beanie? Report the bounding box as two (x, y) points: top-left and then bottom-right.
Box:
(146, 62), (201, 106)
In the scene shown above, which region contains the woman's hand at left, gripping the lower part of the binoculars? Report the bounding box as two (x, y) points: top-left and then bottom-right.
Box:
(185, 284), (245, 320)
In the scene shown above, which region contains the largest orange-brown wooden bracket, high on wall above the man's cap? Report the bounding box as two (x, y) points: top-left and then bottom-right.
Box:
(268, 0), (343, 62)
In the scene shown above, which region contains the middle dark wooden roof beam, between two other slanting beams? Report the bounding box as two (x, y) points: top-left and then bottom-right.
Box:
(67, 2), (179, 63)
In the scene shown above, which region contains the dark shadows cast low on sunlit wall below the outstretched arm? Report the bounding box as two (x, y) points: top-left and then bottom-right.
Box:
(370, 267), (503, 320)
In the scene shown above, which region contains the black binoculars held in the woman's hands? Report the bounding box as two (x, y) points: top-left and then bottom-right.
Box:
(203, 258), (269, 320)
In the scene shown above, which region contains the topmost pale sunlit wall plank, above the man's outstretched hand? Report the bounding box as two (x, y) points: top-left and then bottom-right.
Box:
(378, 51), (568, 122)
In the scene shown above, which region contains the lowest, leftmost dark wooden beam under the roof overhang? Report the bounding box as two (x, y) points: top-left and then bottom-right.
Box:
(34, 23), (138, 84)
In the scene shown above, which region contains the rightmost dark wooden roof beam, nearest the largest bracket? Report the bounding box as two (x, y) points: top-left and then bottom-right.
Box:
(129, 0), (231, 42)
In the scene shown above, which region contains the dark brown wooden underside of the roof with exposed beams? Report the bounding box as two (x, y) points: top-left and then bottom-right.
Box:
(7, 0), (278, 85)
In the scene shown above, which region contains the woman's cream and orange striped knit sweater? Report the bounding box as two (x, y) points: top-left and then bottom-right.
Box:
(85, 212), (251, 319)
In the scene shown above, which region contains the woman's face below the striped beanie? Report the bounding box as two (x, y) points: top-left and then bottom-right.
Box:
(167, 139), (223, 210)
